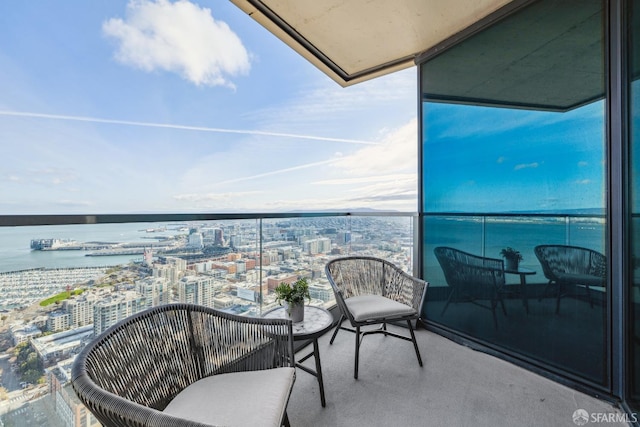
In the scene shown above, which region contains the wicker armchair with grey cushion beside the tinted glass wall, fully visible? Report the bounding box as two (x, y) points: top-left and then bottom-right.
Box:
(325, 256), (428, 379)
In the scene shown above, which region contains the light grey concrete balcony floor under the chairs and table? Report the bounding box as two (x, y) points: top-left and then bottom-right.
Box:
(288, 329), (628, 427)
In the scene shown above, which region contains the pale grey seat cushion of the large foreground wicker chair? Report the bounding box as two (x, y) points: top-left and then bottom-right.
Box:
(164, 368), (295, 427)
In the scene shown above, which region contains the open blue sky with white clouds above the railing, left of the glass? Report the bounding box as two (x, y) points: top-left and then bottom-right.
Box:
(0, 0), (417, 214)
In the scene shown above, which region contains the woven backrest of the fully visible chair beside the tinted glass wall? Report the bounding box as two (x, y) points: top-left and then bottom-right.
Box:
(325, 256), (427, 313)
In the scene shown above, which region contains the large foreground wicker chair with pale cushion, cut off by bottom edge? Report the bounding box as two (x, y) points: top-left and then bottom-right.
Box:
(72, 304), (295, 427)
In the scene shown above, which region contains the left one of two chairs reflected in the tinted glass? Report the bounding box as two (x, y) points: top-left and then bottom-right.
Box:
(434, 246), (507, 328)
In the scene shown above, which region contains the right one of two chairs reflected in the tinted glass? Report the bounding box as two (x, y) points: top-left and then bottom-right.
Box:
(534, 245), (607, 313)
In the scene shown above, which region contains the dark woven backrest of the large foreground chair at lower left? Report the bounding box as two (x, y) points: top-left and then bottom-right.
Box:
(72, 304), (293, 413)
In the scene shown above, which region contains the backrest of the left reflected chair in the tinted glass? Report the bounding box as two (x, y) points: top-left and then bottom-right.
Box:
(433, 246), (505, 287)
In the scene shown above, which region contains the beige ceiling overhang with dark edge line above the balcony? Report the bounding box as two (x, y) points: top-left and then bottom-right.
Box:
(231, 0), (512, 86)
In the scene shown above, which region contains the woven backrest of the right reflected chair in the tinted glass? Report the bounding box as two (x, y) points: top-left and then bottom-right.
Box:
(534, 245), (607, 281)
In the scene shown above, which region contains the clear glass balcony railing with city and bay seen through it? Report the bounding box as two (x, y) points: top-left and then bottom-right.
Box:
(0, 213), (417, 426)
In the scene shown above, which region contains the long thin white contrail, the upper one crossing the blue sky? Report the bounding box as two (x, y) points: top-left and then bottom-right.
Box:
(0, 111), (380, 145)
